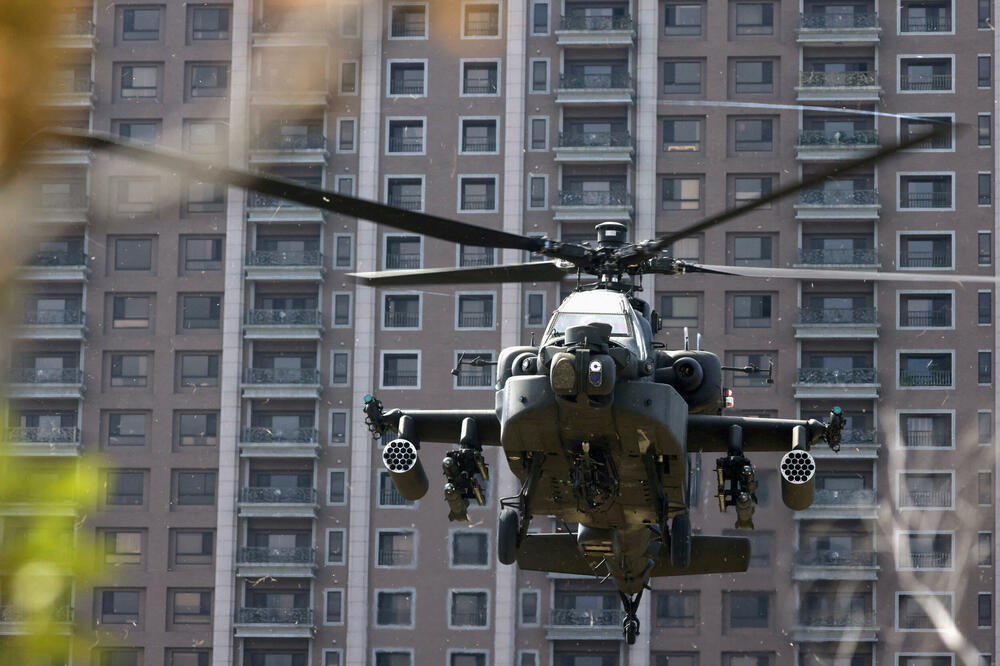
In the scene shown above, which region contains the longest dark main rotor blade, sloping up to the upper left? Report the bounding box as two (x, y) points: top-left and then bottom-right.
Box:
(35, 129), (548, 253)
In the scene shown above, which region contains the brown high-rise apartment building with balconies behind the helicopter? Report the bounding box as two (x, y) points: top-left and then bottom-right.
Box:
(0, 0), (997, 666)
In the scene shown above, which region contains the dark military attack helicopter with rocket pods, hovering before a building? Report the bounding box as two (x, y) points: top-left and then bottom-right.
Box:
(31, 125), (994, 644)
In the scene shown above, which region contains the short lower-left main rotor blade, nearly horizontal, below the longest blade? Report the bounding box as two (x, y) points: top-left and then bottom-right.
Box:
(348, 261), (574, 287)
